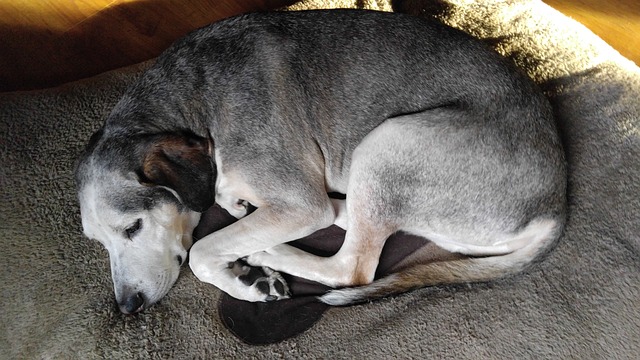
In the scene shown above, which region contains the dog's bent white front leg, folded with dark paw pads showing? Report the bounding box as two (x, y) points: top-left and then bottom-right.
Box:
(189, 204), (335, 302)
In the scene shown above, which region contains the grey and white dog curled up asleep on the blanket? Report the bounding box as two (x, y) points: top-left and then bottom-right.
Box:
(76, 10), (566, 313)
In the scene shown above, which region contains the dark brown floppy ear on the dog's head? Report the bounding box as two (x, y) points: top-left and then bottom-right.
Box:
(138, 133), (216, 212)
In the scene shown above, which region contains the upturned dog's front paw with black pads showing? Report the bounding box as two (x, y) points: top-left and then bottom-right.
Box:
(229, 260), (291, 301)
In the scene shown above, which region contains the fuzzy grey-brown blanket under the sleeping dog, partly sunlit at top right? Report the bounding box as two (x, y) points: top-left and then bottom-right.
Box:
(0, 0), (640, 359)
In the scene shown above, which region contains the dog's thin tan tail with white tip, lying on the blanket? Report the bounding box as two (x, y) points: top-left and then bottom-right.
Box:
(319, 219), (564, 306)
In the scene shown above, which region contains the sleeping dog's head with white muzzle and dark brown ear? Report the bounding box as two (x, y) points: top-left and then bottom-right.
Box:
(76, 130), (216, 314)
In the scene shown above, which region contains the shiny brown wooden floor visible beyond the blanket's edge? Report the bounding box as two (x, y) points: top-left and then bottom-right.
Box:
(0, 0), (640, 91)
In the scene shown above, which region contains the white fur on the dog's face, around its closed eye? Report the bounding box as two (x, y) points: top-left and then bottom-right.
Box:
(80, 183), (200, 307)
